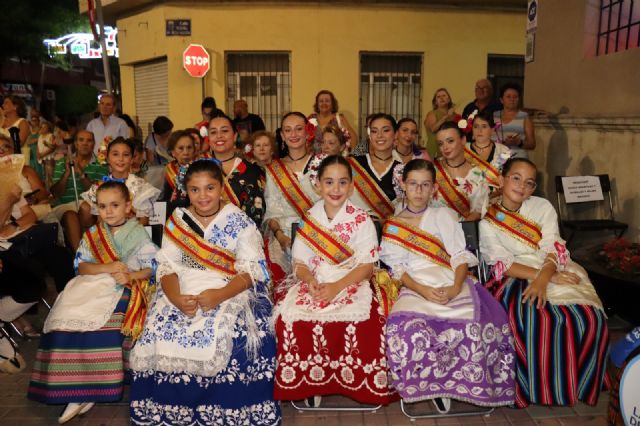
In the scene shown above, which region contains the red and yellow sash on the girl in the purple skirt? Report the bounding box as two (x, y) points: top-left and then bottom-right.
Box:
(382, 219), (451, 269)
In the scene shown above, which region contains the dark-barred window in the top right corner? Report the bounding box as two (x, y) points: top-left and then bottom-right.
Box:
(596, 0), (640, 55)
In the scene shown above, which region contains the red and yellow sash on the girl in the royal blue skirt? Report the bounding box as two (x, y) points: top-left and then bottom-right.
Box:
(164, 212), (236, 277)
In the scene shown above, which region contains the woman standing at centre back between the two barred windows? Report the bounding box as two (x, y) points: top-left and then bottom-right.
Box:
(308, 90), (358, 153)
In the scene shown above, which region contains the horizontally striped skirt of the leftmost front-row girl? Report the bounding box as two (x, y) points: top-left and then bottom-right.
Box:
(27, 289), (130, 404)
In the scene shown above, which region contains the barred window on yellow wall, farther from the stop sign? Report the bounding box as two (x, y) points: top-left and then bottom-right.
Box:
(360, 53), (422, 135)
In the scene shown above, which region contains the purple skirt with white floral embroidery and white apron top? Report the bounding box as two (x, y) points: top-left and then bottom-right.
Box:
(387, 280), (515, 406)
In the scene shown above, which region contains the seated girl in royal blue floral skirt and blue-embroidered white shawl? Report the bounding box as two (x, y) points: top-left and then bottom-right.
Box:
(130, 160), (280, 425)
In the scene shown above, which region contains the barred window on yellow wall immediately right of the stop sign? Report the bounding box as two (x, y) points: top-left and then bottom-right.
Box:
(225, 52), (291, 132)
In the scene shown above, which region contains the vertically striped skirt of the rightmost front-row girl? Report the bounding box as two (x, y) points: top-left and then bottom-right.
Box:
(496, 278), (609, 408)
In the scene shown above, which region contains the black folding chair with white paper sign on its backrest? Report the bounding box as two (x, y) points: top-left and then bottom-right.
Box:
(555, 175), (629, 245)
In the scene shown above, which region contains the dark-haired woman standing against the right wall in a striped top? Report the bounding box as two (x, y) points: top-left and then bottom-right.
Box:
(493, 83), (536, 158)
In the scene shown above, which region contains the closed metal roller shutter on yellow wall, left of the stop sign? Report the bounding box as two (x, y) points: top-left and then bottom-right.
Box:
(133, 58), (169, 140)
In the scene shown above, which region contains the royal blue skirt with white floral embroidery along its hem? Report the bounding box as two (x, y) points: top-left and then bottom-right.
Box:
(130, 300), (281, 426)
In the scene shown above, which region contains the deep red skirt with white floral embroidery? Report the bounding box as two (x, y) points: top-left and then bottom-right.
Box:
(274, 298), (397, 405)
